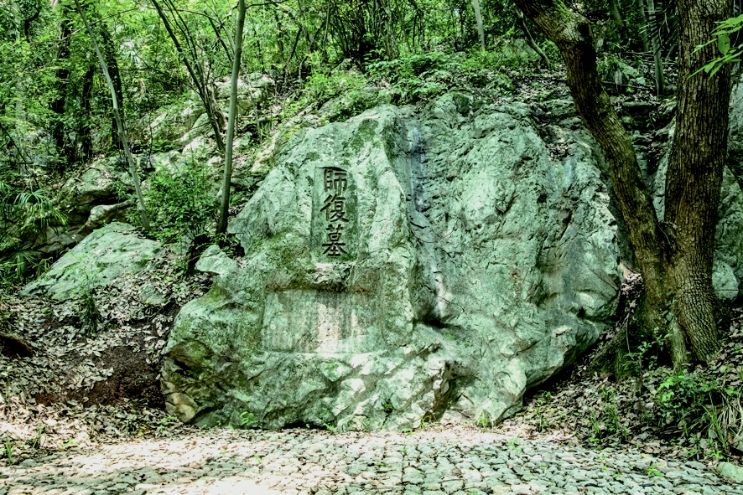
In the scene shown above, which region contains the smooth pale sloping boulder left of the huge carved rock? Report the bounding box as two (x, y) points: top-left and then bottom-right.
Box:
(23, 222), (160, 300)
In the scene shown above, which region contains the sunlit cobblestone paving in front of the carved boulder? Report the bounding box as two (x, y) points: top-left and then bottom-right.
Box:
(0, 428), (743, 495)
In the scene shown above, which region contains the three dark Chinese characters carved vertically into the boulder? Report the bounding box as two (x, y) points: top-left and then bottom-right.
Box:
(312, 166), (355, 261)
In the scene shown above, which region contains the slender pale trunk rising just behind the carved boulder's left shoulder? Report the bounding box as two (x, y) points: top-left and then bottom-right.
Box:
(217, 0), (246, 235)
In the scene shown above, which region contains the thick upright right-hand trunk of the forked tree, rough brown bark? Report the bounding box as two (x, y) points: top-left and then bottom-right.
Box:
(664, 0), (733, 361)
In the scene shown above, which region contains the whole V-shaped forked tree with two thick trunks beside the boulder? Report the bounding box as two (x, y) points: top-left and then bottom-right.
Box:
(515, 0), (731, 366)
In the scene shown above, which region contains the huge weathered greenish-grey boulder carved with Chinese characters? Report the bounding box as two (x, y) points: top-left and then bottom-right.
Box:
(163, 95), (619, 429)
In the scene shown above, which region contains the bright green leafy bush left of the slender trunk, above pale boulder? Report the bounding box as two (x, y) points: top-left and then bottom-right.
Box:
(130, 162), (216, 242)
